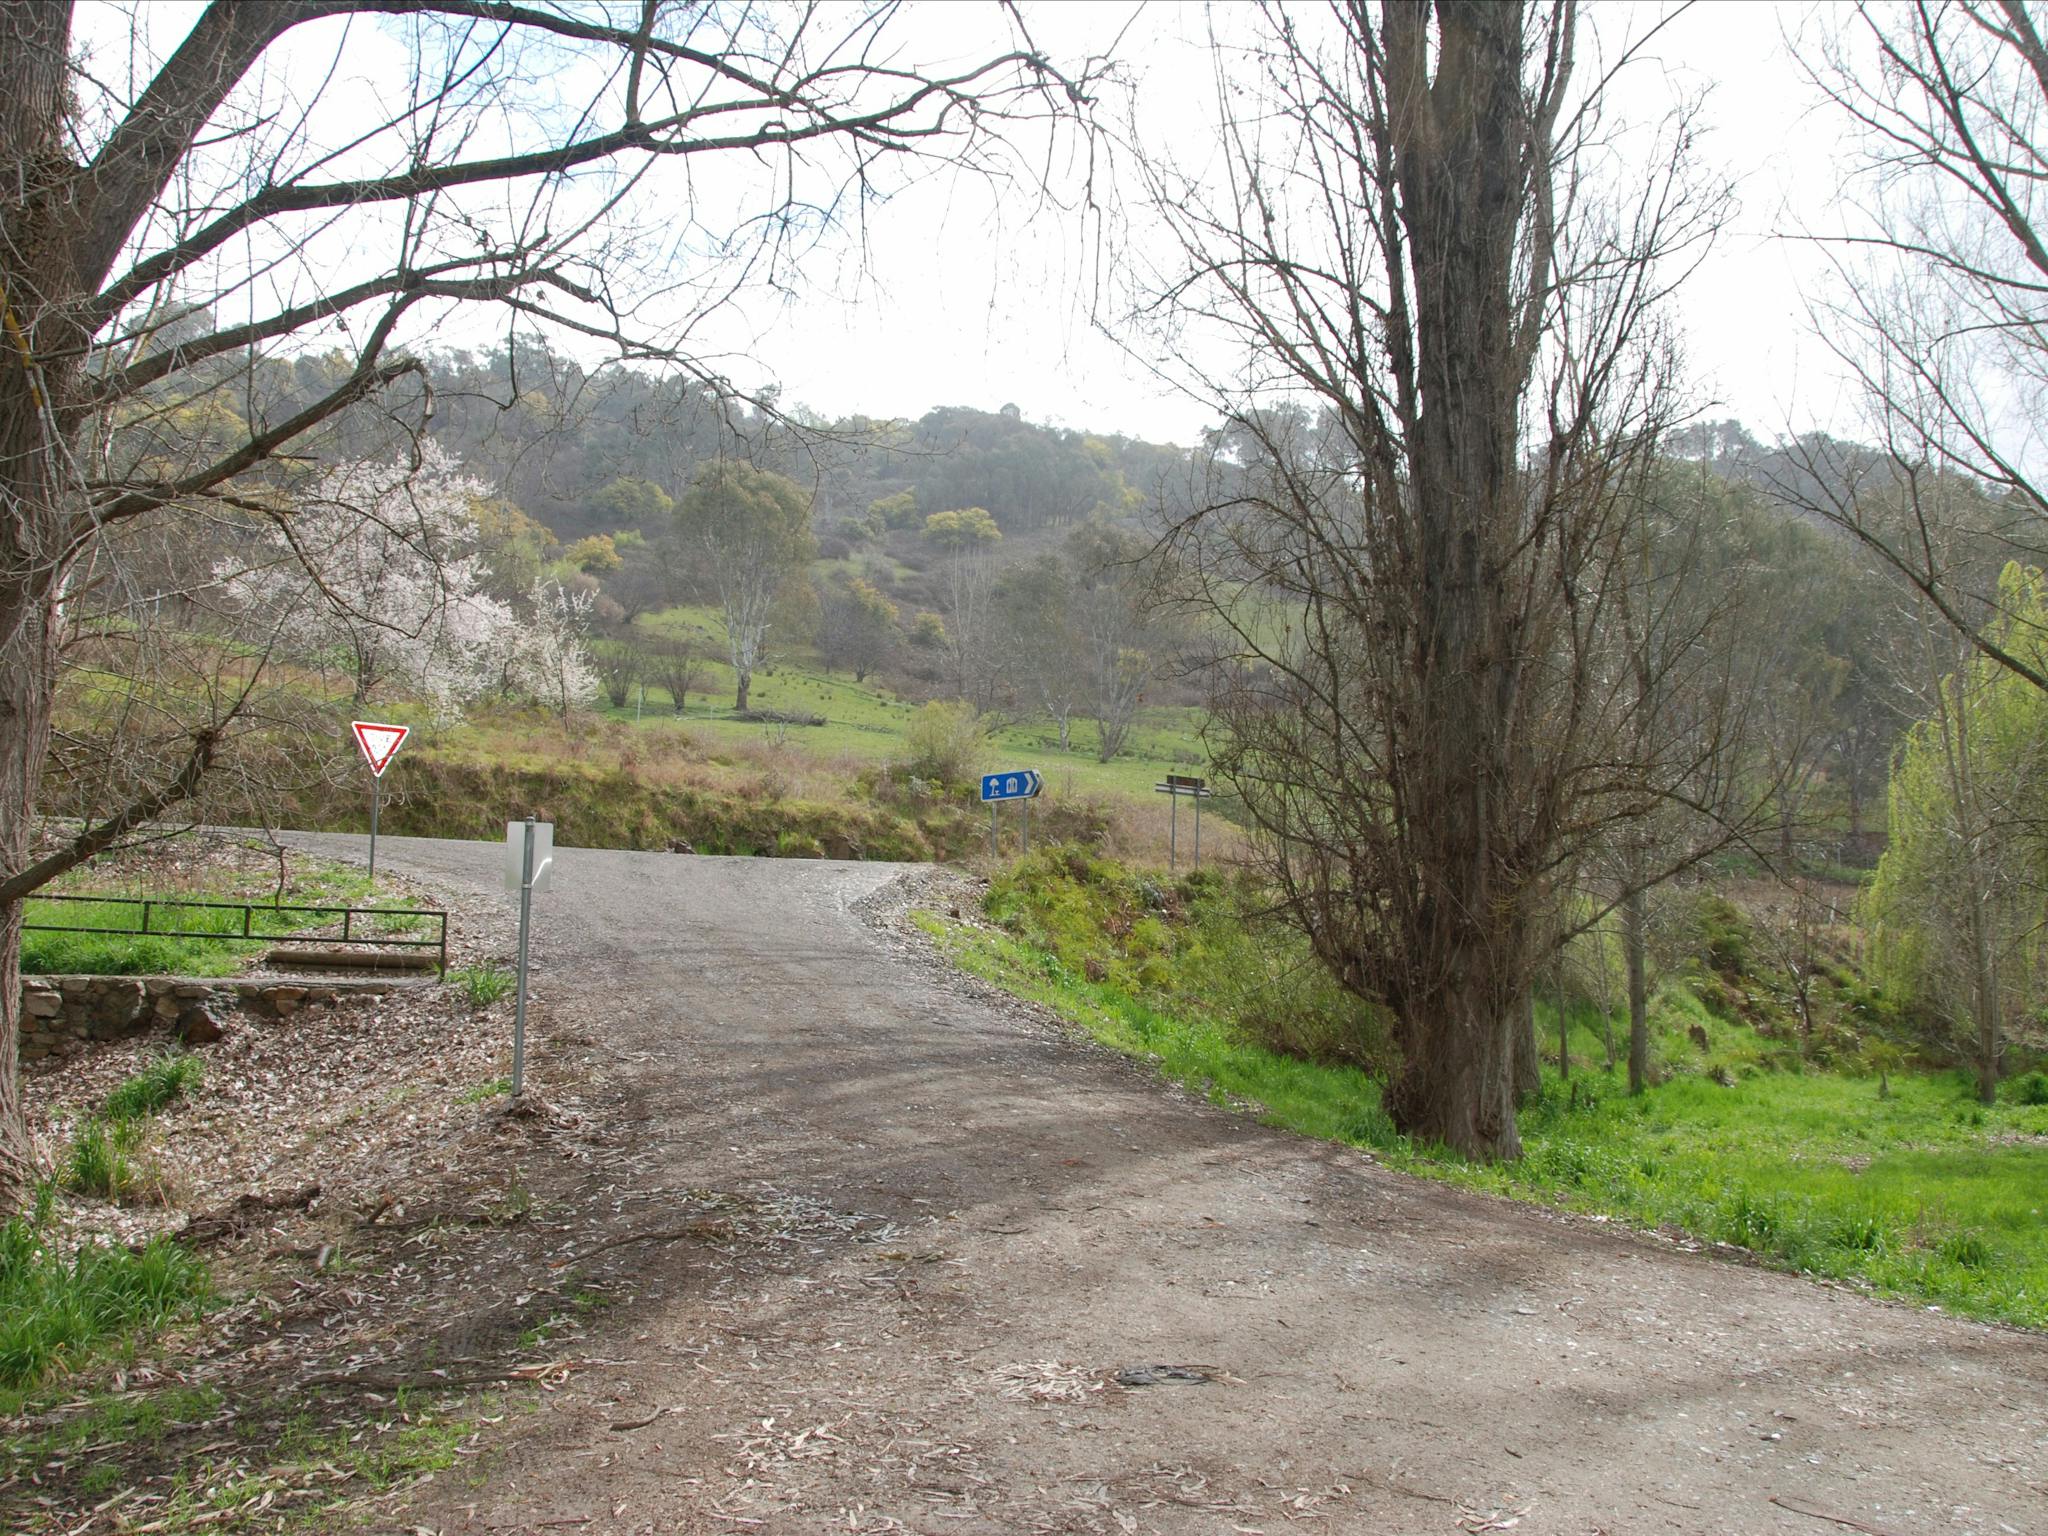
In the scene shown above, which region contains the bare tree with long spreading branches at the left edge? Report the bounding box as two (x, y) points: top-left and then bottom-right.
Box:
(0, 0), (1083, 1196)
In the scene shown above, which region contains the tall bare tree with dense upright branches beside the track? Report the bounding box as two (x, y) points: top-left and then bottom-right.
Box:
(1147, 0), (1722, 1157)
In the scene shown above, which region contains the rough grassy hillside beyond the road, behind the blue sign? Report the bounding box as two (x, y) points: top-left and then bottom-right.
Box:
(289, 610), (1237, 864)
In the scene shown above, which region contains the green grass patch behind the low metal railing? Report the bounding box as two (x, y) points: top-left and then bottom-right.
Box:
(20, 856), (426, 977)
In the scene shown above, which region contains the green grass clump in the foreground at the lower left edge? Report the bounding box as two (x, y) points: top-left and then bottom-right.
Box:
(0, 1190), (207, 1407)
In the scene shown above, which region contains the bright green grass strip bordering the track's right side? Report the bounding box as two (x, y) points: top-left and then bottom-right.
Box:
(920, 870), (2048, 1327)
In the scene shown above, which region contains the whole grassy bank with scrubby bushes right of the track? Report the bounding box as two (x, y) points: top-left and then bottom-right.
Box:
(928, 850), (2048, 1327)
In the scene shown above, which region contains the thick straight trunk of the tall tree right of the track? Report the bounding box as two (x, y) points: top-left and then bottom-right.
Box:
(1380, 6), (1540, 1159)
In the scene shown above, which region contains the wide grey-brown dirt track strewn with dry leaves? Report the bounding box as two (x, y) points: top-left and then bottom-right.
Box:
(307, 840), (2048, 1536)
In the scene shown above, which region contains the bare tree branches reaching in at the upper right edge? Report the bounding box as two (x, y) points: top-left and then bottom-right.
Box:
(1782, 0), (2048, 688)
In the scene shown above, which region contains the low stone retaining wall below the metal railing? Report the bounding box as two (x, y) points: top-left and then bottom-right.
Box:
(20, 977), (403, 1061)
